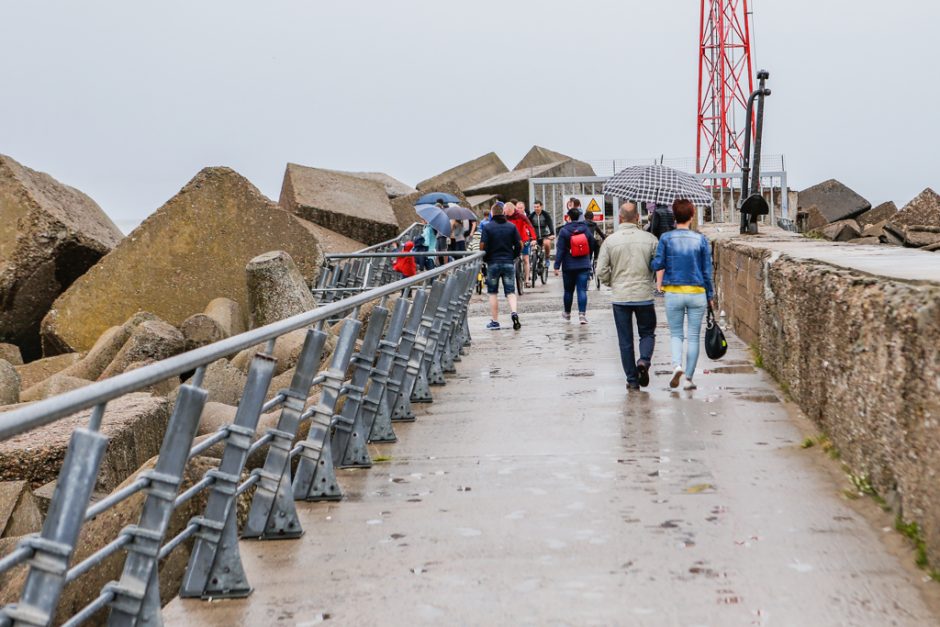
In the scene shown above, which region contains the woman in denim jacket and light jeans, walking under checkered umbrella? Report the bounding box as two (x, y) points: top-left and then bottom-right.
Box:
(650, 200), (715, 390)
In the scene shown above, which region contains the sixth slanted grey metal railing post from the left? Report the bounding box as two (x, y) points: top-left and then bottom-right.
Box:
(332, 306), (388, 468)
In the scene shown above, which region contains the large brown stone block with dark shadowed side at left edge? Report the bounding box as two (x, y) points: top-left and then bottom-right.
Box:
(0, 155), (122, 361)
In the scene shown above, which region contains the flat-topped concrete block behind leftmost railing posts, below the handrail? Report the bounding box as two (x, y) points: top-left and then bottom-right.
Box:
(0, 392), (170, 491)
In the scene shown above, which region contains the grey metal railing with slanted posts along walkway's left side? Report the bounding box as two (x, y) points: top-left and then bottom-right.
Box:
(0, 227), (482, 626)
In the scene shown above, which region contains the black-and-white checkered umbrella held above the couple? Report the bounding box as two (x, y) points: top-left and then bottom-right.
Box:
(604, 164), (714, 207)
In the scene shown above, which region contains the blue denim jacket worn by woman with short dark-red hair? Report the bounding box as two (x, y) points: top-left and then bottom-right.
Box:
(650, 229), (715, 300)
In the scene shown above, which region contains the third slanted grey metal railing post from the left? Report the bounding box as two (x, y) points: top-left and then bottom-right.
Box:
(180, 353), (277, 598)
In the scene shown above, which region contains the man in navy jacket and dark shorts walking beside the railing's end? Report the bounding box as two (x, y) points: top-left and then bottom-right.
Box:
(480, 202), (522, 331)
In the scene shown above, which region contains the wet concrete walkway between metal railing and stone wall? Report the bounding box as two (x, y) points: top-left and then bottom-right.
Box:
(164, 277), (938, 626)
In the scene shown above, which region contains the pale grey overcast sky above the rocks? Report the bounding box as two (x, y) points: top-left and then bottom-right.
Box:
(0, 0), (940, 228)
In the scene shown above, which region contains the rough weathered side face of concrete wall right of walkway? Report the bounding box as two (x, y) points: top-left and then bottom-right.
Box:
(715, 240), (940, 569)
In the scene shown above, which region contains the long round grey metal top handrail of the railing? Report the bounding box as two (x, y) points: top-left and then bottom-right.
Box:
(0, 253), (483, 440)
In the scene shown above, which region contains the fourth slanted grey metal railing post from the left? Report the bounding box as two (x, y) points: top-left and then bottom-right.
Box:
(242, 331), (327, 540)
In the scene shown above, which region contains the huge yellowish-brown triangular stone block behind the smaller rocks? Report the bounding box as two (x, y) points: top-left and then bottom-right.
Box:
(42, 168), (323, 354)
